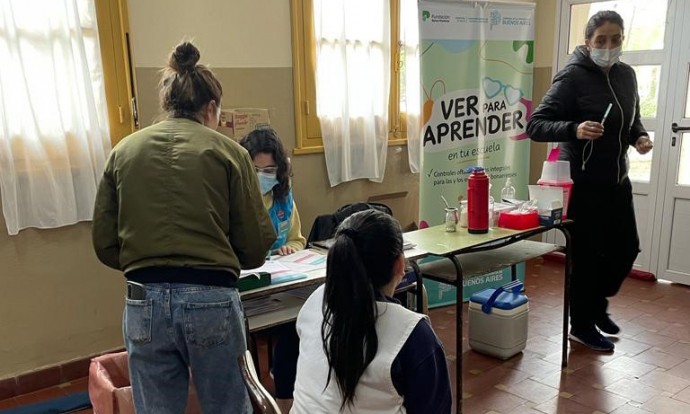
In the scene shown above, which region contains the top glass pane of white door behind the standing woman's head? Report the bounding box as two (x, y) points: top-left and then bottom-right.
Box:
(568, 0), (668, 53)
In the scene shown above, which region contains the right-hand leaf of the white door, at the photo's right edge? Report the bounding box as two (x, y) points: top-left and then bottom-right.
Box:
(655, 1), (690, 285)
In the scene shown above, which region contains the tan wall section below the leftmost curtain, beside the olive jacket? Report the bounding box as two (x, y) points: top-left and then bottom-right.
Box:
(0, 210), (124, 379)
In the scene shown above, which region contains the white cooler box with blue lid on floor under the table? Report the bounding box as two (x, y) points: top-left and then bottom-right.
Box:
(469, 281), (529, 359)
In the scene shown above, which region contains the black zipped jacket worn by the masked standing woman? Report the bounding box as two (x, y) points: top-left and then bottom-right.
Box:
(527, 46), (647, 185)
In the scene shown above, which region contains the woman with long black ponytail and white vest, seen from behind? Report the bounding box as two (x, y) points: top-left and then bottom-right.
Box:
(290, 210), (451, 414)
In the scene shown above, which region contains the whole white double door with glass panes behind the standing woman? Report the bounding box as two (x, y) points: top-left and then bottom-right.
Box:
(554, 0), (690, 284)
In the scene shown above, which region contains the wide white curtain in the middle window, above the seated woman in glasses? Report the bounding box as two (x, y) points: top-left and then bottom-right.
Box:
(314, 0), (391, 186)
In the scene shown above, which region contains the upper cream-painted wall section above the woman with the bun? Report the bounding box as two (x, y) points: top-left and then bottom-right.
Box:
(128, 0), (292, 68)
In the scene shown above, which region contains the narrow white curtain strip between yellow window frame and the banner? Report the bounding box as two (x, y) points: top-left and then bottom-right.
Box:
(400, 0), (422, 173)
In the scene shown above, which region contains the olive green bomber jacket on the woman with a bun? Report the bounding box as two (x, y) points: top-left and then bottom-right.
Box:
(93, 118), (276, 275)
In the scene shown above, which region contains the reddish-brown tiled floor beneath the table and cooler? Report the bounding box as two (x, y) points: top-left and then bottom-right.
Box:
(0, 260), (690, 414)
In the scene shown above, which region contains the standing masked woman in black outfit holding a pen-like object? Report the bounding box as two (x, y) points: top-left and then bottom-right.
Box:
(527, 11), (652, 351)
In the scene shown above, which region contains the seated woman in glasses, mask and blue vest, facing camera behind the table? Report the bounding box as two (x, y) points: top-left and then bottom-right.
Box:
(240, 127), (307, 413)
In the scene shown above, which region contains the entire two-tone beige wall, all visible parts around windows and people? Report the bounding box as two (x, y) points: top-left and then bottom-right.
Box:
(0, 0), (555, 379)
